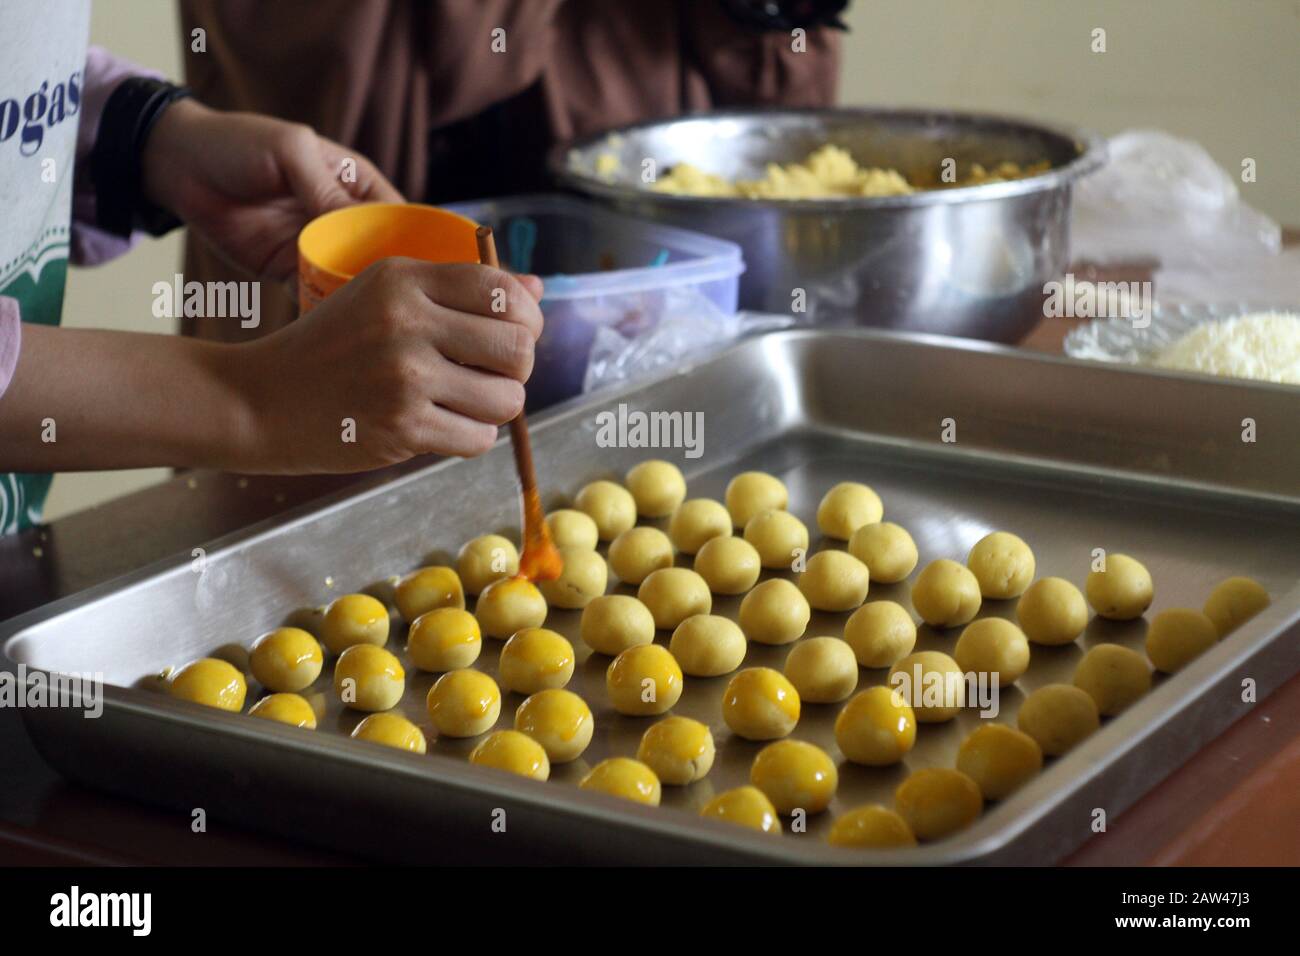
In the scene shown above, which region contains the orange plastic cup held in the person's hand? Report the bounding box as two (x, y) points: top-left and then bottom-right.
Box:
(298, 203), (478, 312)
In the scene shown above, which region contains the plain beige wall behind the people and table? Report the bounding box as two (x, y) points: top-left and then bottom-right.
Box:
(47, 0), (1300, 518)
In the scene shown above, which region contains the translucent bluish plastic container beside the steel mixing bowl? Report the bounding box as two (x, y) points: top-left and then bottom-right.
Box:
(443, 194), (745, 410)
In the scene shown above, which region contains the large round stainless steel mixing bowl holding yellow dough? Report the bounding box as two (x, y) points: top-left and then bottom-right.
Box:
(551, 109), (1105, 342)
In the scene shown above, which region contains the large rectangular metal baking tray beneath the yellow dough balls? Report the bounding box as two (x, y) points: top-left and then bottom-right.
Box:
(0, 332), (1300, 864)
